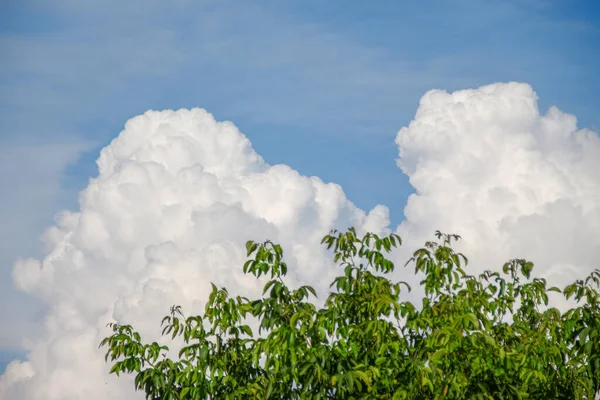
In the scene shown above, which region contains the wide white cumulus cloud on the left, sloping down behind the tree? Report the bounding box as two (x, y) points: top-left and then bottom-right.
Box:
(0, 109), (389, 400)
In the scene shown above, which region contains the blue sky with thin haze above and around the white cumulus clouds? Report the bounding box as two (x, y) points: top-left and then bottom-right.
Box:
(0, 0), (600, 370)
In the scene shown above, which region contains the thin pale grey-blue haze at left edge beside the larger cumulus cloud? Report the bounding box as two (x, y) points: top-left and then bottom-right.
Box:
(0, 142), (89, 351)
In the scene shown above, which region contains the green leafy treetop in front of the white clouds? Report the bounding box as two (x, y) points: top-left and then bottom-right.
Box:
(101, 229), (600, 400)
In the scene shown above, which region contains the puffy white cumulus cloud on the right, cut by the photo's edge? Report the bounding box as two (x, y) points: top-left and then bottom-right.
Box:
(396, 83), (600, 294)
